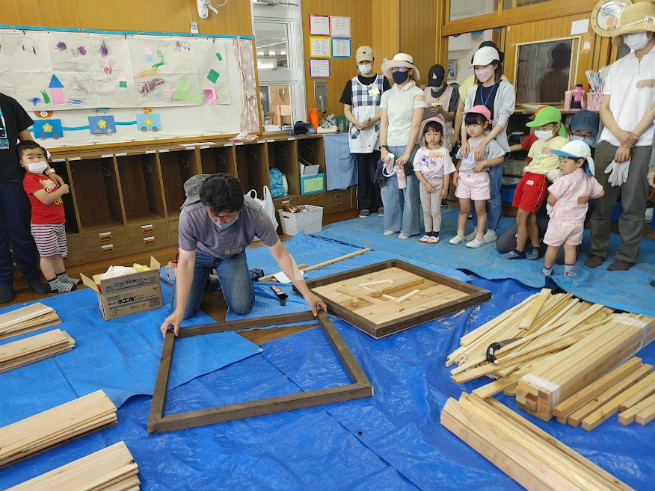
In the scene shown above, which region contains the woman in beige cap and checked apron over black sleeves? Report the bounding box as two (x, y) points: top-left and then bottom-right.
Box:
(340, 46), (391, 218)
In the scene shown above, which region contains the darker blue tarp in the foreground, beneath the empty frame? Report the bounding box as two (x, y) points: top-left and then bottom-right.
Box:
(0, 236), (655, 490)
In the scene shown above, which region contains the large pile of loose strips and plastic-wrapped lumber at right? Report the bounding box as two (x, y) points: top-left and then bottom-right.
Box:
(446, 289), (655, 422)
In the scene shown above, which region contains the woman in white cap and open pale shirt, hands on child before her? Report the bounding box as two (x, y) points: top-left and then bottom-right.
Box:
(460, 46), (516, 243)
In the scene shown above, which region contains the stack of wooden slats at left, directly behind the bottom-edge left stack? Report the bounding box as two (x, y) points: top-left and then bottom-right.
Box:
(0, 390), (116, 467)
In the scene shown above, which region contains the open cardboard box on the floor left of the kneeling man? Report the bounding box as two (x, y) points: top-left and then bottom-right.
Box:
(80, 257), (163, 320)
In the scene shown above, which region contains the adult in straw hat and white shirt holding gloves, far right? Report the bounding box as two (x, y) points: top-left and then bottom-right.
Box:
(585, 2), (655, 271)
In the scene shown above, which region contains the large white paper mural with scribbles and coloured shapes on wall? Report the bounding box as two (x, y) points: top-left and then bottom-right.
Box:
(0, 30), (232, 111)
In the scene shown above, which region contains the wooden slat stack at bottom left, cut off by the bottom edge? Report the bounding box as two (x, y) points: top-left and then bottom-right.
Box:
(7, 442), (140, 491)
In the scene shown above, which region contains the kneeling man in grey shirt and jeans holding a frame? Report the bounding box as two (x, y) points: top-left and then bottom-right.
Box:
(160, 174), (326, 336)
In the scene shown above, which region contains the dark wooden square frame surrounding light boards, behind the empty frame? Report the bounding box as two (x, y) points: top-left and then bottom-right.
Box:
(307, 259), (491, 339)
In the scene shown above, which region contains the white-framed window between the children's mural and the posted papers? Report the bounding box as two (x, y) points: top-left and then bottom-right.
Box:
(252, 1), (306, 132)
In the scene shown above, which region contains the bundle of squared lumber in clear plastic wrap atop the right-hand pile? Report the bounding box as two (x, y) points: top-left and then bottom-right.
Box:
(516, 314), (655, 421)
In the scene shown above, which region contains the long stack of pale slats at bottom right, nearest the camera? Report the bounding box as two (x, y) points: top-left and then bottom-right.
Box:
(441, 393), (630, 490)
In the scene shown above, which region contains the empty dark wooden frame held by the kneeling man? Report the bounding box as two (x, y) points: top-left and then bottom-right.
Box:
(147, 312), (373, 433)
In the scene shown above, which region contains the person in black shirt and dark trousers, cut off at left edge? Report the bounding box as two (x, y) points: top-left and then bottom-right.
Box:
(0, 93), (64, 303)
